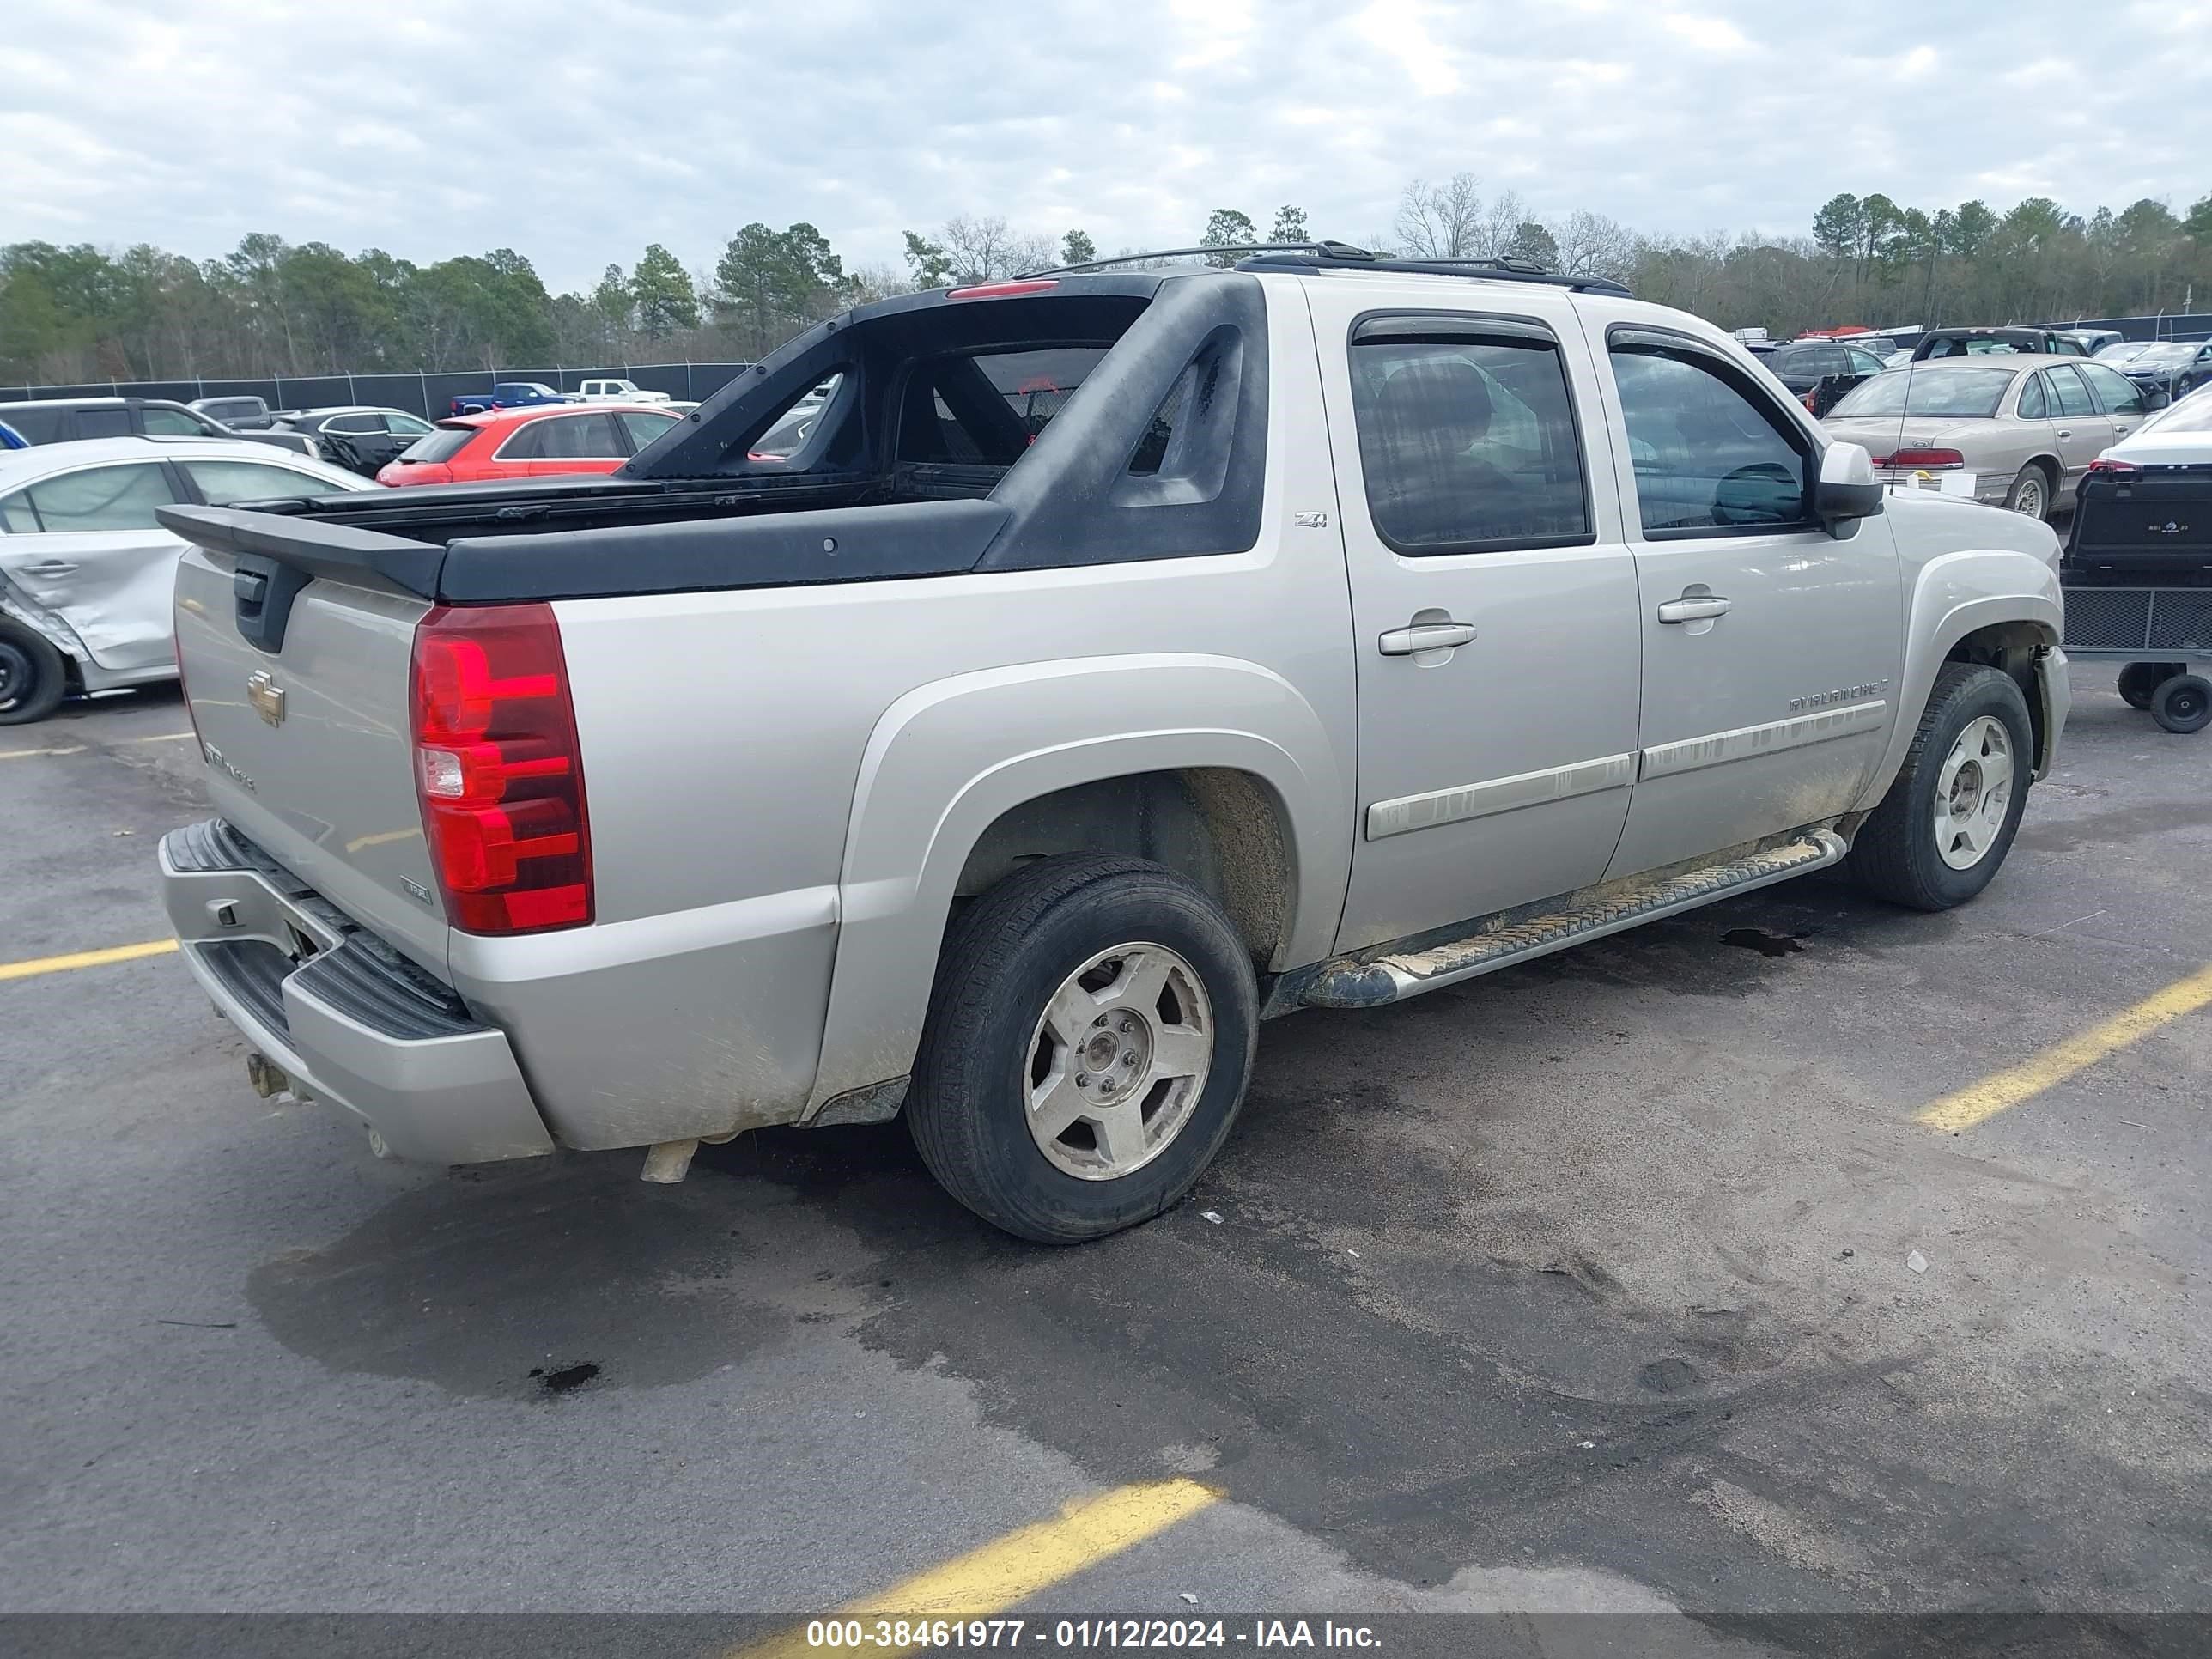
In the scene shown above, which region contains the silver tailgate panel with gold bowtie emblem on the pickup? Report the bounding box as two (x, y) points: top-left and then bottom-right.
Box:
(177, 539), (447, 978)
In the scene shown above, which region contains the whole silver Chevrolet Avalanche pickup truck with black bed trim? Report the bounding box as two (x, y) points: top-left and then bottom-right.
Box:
(161, 243), (2066, 1241)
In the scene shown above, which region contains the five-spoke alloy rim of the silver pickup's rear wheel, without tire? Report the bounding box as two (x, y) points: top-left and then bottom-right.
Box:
(1022, 940), (1214, 1182)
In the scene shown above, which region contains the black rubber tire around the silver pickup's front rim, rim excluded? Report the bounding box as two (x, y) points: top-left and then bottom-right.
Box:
(1851, 661), (2035, 909)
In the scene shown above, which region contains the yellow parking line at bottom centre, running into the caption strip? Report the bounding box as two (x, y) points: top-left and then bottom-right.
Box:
(730, 1480), (1221, 1659)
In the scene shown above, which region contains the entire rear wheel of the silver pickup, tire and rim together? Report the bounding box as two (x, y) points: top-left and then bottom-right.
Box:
(905, 854), (1259, 1243)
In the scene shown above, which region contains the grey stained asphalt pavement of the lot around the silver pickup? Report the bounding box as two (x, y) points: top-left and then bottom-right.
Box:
(0, 664), (2212, 1652)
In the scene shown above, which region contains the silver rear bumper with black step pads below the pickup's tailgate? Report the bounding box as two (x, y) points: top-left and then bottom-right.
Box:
(161, 818), (553, 1164)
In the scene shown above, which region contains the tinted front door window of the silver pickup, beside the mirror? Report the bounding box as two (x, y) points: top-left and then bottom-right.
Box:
(1610, 345), (1805, 535)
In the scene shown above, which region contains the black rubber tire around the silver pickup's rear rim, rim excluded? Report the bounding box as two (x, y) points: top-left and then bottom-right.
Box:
(905, 854), (1259, 1243)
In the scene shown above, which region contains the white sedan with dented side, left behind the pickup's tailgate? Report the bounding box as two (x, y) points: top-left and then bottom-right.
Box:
(0, 438), (376, 726)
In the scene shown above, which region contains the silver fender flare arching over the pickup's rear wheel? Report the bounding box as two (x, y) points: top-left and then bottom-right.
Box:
(807, 654), (1352, 1117)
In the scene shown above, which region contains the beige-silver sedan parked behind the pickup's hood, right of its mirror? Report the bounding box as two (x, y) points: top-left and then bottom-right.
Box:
(1823, 354), (2161, 518)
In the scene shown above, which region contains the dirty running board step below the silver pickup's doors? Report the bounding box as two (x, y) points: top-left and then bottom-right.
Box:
(1298, 830), (1850, 1009)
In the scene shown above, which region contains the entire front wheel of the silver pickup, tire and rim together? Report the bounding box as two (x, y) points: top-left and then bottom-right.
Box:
(1851, 661), (2033, 909)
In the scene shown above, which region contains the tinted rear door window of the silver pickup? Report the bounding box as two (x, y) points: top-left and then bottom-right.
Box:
(1352, 337), (1590, 556)
